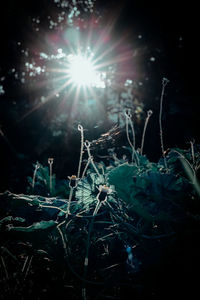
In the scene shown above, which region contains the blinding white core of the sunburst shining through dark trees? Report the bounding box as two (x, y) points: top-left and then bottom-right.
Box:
(68, 54), (105, 88)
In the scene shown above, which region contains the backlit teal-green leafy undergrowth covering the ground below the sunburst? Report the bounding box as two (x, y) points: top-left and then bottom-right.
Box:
(0, 138), (200, 299)
